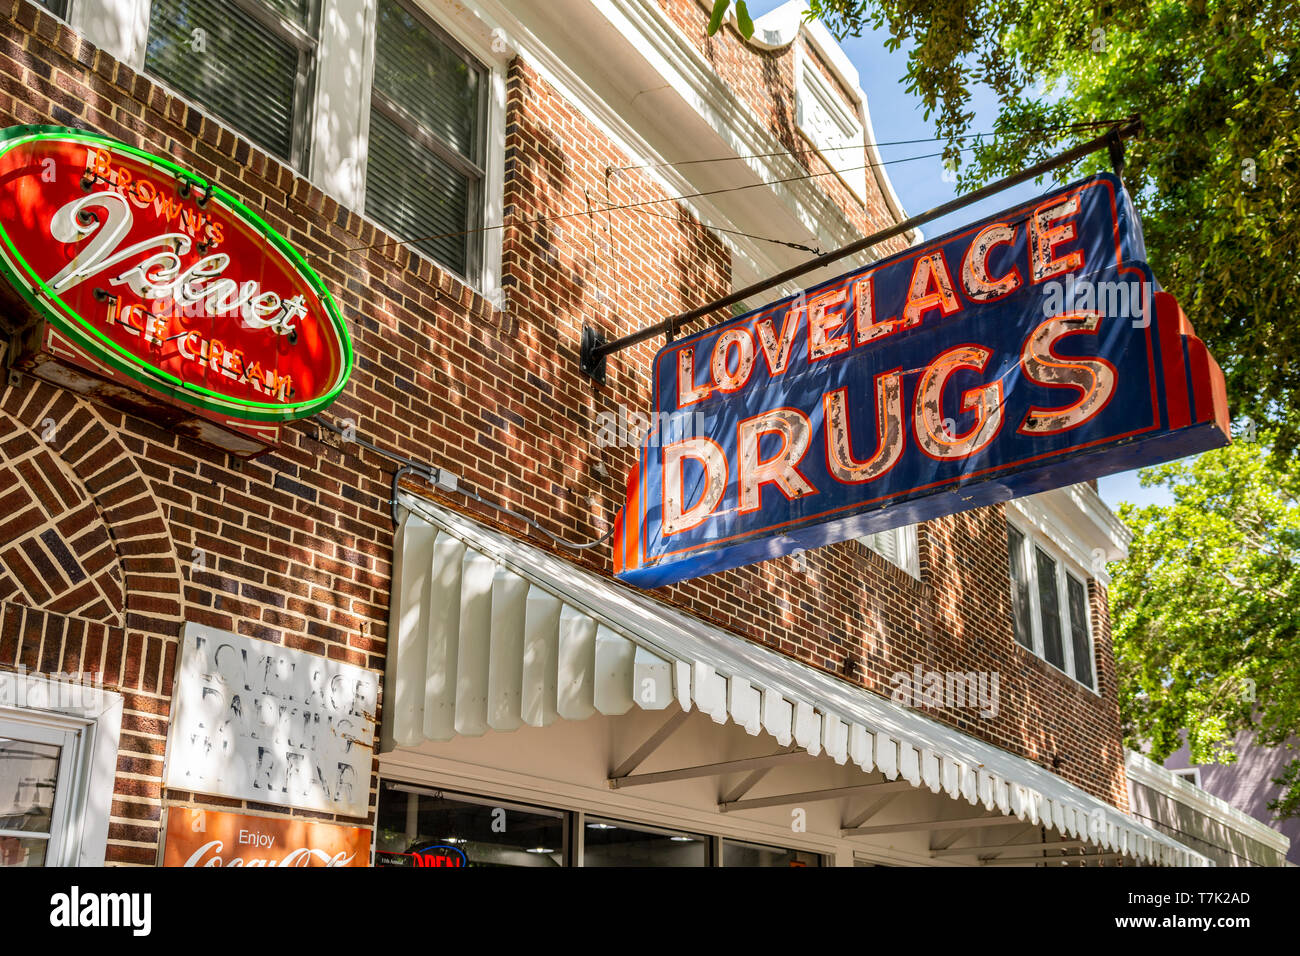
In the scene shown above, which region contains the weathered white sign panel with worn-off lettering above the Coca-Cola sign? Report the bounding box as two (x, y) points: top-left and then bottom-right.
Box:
(164, 623), (378, 817)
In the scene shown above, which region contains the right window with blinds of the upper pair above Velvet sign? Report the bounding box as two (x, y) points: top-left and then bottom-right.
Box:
(365, 0), (488, 281)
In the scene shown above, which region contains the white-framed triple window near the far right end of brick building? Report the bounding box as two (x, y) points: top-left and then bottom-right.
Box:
(1006, 522), (1096, 688)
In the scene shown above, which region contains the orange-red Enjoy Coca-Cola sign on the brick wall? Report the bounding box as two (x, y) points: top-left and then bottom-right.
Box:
(163, 806), (371, 866)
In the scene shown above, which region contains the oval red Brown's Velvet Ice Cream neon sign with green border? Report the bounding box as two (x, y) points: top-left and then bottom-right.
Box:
(0, 126), (352, 423)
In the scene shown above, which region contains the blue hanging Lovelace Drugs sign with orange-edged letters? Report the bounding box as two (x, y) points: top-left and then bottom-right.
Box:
(614, 173), (1229, 588)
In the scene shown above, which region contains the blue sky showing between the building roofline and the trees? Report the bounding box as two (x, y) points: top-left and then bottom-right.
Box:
(748, 0), (1173, 509)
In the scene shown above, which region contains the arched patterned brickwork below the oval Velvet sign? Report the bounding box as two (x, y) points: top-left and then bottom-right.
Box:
(0, 377), (182, 689)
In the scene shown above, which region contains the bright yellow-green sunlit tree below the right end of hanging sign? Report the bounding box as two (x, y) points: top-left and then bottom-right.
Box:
(1110, 436), (1300, 816)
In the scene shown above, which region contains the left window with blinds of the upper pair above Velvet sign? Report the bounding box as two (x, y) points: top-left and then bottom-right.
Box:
(144, 0), (319, 168)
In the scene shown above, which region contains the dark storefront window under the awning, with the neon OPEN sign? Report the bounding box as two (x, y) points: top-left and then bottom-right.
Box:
(374, 783), (567, 866)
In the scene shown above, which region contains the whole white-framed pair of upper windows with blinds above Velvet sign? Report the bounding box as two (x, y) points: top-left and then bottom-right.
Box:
(78, 0), (508, 291)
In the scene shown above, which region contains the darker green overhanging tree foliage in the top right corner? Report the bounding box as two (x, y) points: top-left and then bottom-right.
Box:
(719, 0), (1300, 455)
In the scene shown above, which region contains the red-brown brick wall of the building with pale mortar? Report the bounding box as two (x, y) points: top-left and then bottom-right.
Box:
(0, 0), (1125, 864)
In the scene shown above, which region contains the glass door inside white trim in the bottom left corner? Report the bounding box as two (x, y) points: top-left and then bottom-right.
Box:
(0, 717), (79, 866)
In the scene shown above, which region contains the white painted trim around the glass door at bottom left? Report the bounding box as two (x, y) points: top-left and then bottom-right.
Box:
(0, 671), (122, 866)
